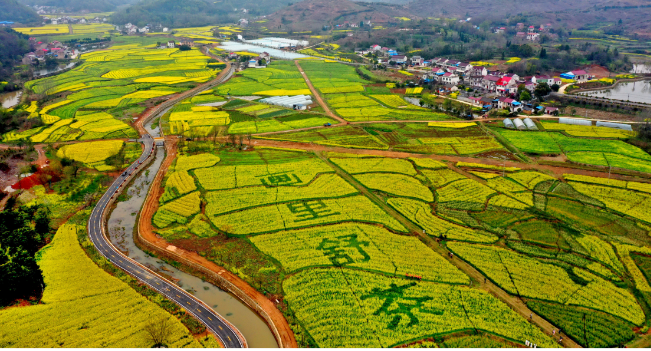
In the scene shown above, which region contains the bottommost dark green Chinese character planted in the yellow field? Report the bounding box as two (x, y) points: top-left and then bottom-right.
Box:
(360, 282), (443, 330)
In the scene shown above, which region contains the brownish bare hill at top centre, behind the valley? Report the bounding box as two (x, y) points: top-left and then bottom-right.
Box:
(265, 0), (408, 30)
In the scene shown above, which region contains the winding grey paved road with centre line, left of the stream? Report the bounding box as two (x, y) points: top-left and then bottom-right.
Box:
(88, 67), (247, 348)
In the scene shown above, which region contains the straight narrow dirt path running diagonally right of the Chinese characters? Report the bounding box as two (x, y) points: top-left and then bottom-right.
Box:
(317, 153), (581, 348)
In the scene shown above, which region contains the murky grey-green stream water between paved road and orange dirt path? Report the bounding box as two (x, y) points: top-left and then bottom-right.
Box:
(108, 130), (278, 348)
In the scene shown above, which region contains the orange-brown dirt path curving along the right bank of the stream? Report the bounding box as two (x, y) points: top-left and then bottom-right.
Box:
(138, 137), (298, 348)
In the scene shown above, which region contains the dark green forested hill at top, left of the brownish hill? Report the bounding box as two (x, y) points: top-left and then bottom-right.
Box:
(111, 0), (291, 28)
